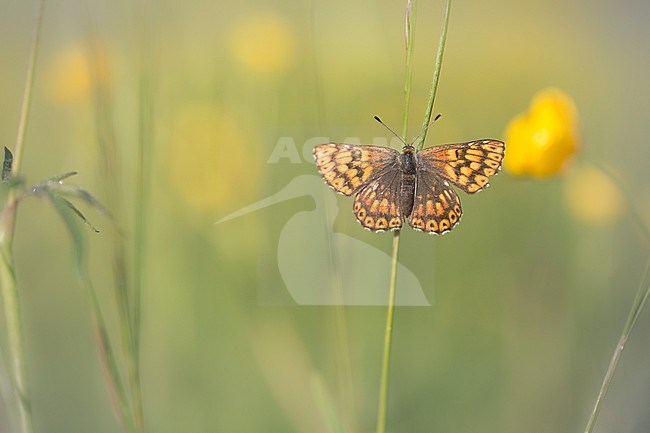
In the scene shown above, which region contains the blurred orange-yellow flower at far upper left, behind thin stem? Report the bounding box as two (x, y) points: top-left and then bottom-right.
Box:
(48, 44), (111, 103)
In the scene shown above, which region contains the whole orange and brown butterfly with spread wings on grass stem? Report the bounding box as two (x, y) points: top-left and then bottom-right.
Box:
(314, 139), (505, 234)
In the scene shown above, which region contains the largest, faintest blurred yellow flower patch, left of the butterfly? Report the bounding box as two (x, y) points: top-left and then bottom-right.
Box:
(167, 103), (257, 211)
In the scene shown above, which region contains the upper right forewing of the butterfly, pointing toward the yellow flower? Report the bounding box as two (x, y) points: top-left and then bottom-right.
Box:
(417, 140), (505, 194)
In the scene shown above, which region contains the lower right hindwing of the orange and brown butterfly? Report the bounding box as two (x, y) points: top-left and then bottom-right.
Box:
(409, 168), (463, 234)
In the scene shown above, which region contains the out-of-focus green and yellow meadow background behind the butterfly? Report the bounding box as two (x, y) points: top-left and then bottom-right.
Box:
(0, 0), (650, 433)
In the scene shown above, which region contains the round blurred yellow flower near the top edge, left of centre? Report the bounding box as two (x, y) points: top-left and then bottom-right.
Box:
(229, 13), (296, 75)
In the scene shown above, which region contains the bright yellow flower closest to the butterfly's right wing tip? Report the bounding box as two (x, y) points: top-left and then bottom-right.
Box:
(505, 88), (580, 176)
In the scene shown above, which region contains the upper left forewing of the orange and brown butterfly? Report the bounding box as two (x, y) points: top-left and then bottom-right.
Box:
(314, 143), (399, 196)
